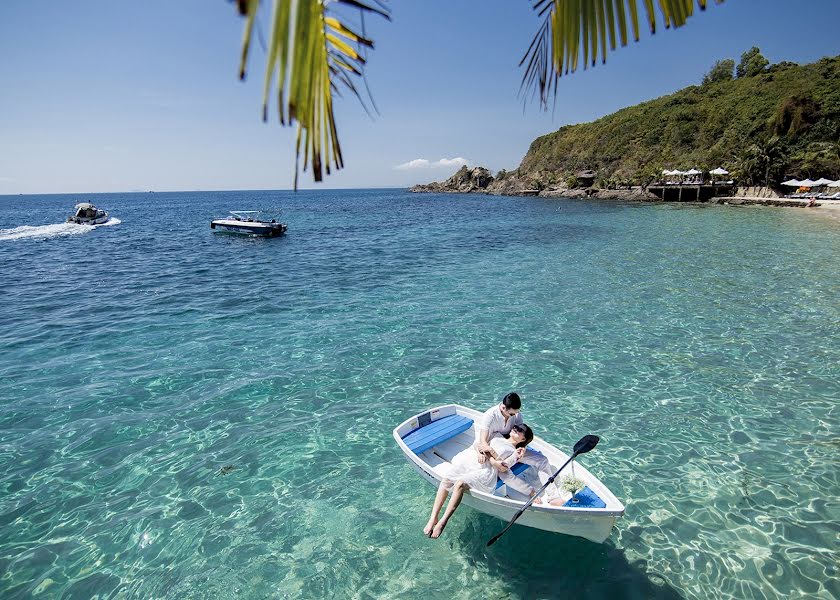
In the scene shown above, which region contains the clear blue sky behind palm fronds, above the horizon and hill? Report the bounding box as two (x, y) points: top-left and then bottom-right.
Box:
(0, 0), (840, 194)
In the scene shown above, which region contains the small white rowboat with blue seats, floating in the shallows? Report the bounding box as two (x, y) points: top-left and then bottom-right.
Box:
(394, 404), (624, 543)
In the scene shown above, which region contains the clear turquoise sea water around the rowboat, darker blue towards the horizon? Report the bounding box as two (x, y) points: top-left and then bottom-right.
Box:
(0, 190), (840, 598)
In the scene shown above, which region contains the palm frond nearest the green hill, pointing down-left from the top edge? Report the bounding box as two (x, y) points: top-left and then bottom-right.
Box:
(519, 0), (723, 108)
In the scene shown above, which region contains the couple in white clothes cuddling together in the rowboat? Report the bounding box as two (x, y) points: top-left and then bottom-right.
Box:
(423, 392), (566, 538)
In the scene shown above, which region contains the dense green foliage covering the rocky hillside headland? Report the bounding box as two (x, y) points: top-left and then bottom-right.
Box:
(520, 54), (840, 185)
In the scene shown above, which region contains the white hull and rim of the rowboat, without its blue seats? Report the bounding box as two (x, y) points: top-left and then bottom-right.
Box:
(394, 404), (624, 543)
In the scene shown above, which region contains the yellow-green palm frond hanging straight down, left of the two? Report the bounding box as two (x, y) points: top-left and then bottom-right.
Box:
(237, 0), (390, 189)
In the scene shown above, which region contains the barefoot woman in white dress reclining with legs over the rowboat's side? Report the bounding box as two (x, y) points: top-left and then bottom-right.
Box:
(423, 424), (536, 538)
